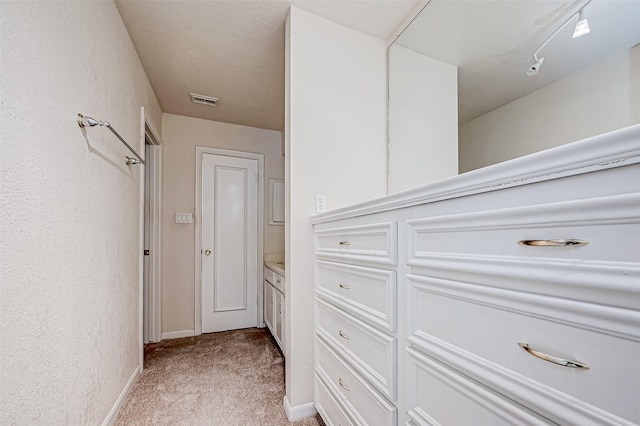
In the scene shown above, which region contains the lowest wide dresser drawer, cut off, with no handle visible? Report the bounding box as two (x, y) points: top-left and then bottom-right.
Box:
(407, 349), (554, 426)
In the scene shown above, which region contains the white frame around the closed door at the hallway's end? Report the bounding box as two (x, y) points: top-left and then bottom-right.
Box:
(194, 146), (264, 336)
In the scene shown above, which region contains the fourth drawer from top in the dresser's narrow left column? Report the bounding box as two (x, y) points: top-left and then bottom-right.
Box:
(316, 338), (397, 426)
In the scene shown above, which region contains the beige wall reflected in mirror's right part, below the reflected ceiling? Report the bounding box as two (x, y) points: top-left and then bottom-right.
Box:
(459, 45), (640, 172)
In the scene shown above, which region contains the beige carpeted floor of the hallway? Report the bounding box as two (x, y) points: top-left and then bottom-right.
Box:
(116, 328), (323, 426)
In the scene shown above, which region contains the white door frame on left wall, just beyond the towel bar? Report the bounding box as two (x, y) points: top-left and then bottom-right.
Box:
(139, 106), (163, 366)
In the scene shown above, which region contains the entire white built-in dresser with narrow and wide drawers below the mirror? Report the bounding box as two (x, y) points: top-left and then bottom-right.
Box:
(313, 126), (640, 426)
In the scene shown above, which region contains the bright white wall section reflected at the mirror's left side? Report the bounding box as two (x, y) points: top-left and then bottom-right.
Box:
(389, 44), (458, 193)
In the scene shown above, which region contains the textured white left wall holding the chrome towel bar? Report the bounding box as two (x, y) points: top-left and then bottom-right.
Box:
(0, 1), (161, 425)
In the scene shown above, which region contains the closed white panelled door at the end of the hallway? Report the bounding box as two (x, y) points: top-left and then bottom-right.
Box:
(201, 153), (258, 333)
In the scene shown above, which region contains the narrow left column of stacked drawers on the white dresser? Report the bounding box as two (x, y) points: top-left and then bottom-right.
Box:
(315, 214), (408, 425)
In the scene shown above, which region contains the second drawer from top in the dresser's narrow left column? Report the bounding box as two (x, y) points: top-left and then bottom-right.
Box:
(316, 261), (397, 333)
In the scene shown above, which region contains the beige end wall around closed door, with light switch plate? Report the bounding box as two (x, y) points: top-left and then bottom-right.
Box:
(162, 114), (284, 338)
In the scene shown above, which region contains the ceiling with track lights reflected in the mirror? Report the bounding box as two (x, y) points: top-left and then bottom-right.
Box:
(398, 0), (640, 124)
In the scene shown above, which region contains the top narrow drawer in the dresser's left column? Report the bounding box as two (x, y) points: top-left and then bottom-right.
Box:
(315, 222), (398, 265)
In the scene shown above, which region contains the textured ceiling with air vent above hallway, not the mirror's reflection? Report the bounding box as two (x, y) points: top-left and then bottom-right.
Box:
(116, 0), (424, 130)
